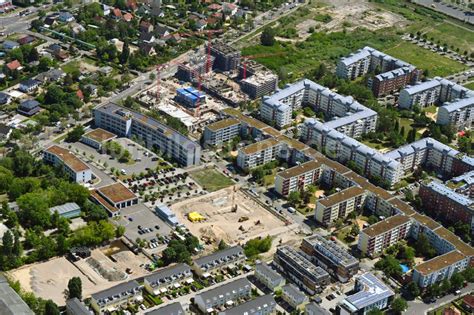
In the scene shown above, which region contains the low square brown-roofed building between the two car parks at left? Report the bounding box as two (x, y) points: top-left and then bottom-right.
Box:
(91, 183), (138, 217)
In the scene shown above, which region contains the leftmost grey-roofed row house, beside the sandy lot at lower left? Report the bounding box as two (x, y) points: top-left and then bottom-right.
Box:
(91, 280), (143, 314)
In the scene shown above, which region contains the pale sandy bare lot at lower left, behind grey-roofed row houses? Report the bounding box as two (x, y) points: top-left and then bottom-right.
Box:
(9, 245), (150, 305)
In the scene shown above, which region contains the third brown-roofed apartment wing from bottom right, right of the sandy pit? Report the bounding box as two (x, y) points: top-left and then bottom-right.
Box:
(314, 186), (365, 226)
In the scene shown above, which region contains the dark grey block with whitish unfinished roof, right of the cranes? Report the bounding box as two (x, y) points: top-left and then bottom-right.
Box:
(240, 71), (278, 99)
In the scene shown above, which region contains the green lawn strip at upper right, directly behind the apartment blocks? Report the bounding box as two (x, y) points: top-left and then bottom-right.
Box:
(384, 42), (467, 77)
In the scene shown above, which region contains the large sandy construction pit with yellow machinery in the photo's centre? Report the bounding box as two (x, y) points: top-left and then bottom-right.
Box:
(171, 187), (300, 245)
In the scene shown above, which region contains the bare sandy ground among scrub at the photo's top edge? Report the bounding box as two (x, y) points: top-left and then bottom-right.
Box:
(296, 1), (407, 40)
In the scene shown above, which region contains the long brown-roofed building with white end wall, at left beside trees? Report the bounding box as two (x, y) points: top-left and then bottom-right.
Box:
(43, 145), (92, 183)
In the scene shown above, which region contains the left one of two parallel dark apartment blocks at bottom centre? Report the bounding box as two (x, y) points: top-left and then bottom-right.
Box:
(273, 246), (330, 295)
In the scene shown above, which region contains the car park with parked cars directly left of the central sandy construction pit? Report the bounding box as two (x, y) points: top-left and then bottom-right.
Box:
(117, 204), (171, 249)
